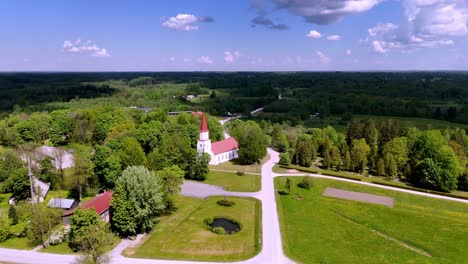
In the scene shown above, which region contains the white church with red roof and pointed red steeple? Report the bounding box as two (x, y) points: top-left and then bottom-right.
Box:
(197, 113), (239, 165)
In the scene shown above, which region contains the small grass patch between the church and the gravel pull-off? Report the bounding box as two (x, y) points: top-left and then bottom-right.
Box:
(204, 171), (261, 192)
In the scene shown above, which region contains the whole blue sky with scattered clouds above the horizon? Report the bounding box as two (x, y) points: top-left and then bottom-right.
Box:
(0, 0), (468, 71)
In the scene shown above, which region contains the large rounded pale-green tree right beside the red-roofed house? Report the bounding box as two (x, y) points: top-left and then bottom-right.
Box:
(111, 166), (166, 235)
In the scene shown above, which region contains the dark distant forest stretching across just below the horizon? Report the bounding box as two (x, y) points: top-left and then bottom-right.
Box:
(0, 72), (468, 123)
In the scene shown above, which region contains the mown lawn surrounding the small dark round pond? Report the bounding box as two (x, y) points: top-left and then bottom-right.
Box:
(124, 196), (261, 261)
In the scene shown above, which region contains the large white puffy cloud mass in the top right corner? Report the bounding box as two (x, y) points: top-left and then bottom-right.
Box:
(365, 0), (468, 54)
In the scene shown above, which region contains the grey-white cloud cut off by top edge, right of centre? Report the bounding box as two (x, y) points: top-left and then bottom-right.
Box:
(251, 0), (382, 25)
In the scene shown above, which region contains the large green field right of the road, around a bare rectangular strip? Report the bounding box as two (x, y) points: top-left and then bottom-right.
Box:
(275, 177), (468, 264)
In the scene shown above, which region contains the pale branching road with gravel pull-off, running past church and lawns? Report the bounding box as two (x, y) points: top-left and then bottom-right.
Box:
(0, 149), (468, 264)
